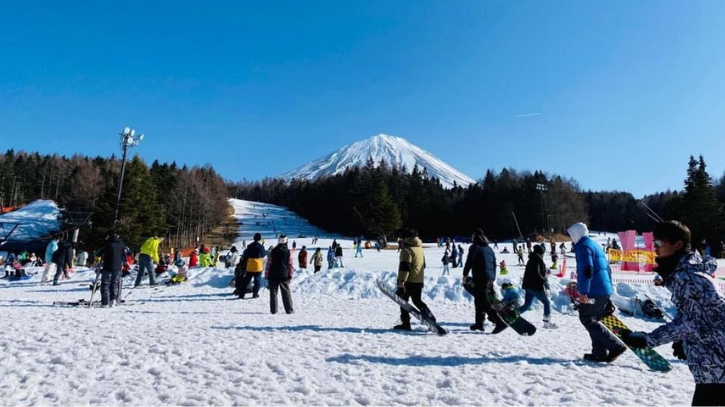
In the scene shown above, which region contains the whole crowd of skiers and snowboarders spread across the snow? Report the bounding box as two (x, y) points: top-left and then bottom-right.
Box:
(3, 215), (725, 405)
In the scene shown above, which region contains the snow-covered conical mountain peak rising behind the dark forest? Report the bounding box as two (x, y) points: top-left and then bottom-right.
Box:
(282, 134), (476, 188)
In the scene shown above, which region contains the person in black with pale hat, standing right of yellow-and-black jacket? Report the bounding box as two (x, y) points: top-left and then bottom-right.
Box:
(264, 233), (295, 314)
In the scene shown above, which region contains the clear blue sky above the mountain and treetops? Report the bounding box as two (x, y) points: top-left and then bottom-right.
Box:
(0, 0), (725, 196)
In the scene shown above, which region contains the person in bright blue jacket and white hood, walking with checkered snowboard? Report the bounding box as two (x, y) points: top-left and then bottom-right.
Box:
(567, 222), (627, 363)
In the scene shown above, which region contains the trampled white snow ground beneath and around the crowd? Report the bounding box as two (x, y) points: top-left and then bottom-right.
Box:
(0, 200), (716, 405)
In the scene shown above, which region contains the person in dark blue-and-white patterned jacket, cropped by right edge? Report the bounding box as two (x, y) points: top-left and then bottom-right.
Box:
(622, 221), (725, 406)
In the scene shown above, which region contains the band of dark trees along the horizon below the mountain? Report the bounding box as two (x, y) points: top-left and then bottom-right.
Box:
(0, 149), (725, 258)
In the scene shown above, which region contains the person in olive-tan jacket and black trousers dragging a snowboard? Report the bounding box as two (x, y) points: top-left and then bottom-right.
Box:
(393, 229), (436, 331)
